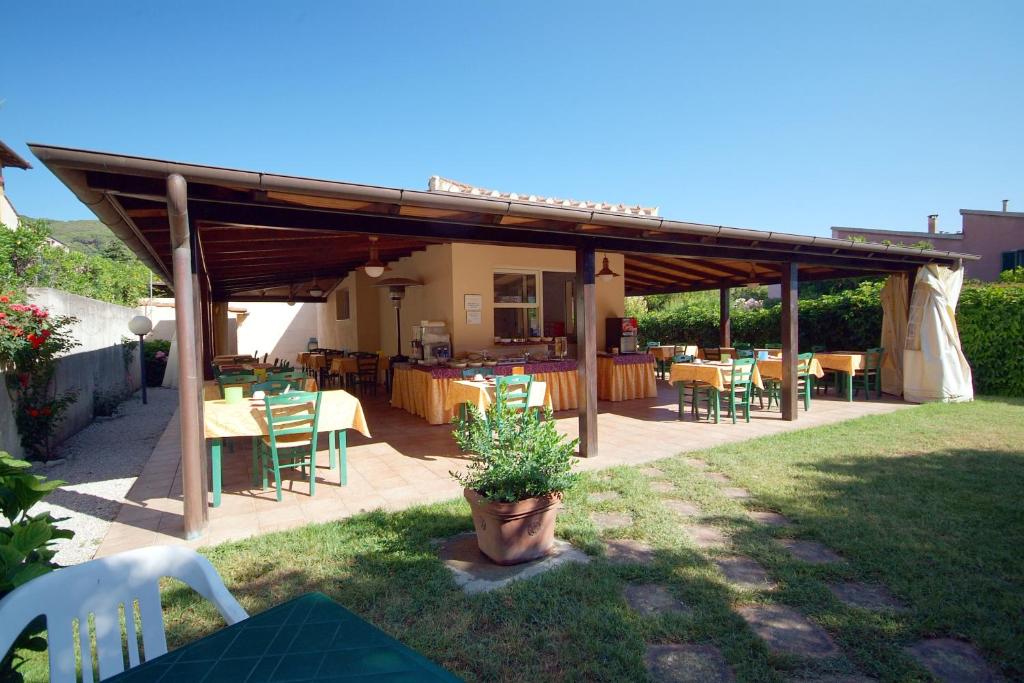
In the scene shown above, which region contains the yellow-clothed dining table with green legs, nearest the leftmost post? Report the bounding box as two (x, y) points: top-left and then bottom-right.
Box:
(203, 382), (370, 507)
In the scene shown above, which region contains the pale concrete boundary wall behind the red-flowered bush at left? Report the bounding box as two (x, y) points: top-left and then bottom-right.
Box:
(0, 288), (143, 457)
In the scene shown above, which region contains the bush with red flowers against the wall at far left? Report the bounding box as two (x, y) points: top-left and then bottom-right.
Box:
(0, 294), (78, 459)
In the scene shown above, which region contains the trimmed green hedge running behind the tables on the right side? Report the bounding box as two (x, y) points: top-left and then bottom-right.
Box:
(638, 283), (1024, 396)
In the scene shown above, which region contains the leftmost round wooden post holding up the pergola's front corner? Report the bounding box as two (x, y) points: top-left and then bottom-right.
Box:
(167, 173), (208, 539)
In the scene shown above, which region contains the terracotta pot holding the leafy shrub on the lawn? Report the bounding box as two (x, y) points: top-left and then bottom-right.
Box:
(463, 488), (562, 564)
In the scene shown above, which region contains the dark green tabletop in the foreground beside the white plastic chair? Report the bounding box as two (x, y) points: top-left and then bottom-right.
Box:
(108, 593), (459, 683)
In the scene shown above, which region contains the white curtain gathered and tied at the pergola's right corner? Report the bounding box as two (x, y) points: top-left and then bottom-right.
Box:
(903, 265), (974, 403)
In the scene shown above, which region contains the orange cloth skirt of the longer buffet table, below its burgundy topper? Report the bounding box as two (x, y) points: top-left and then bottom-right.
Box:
(391, 368), (579, 425)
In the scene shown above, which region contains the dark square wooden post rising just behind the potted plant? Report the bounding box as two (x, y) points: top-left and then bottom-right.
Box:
(575, 247), (597, 458)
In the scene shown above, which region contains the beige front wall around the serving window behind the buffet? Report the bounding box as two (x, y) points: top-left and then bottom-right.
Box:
(449, 244), (626, 351)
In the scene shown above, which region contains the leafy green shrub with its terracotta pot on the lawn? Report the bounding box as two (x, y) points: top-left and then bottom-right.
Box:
(452, 400), (579, 564)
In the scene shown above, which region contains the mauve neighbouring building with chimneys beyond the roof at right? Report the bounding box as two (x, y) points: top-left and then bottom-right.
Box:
(831, 200), (1024, 282)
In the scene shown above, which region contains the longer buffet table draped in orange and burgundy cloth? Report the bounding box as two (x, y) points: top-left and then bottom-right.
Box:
(391, 359), (577, 425)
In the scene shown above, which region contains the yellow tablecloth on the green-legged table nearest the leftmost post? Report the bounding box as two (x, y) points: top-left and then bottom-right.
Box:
(203, 389), (370, 438)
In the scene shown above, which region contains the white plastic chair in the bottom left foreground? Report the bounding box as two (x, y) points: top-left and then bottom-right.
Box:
(0, 546), (249, 683)
